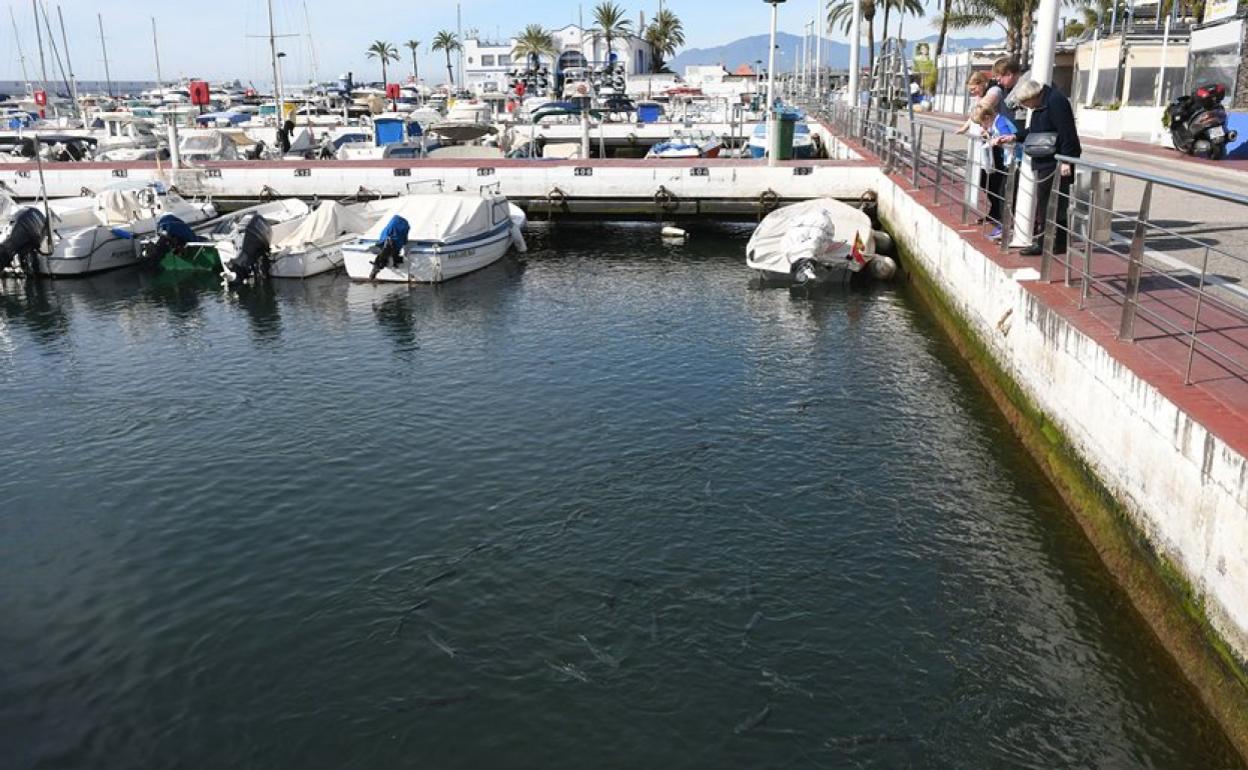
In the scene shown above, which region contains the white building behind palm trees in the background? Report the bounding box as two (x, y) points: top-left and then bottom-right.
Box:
(462, 24), (651, 92)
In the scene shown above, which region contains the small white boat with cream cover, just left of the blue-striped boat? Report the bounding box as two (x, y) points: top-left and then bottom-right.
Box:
(216, 198), (394, 282)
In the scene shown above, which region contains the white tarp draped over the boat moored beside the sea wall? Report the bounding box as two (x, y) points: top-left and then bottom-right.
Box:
(745, 198), (875, 272)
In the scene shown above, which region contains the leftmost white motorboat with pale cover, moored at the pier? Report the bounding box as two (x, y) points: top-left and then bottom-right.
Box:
(35, 182), (217, 276)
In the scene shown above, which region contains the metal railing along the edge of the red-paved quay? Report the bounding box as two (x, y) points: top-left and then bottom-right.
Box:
(809, 96), (1248, 384)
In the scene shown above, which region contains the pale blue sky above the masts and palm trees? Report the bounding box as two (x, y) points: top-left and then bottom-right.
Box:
(0, 0), (973, 87)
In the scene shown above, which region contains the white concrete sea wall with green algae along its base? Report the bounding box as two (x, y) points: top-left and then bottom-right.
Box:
(876, 173), (1248, 755)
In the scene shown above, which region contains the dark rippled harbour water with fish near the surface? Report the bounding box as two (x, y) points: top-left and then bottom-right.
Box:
(0, 226), (1239, 769)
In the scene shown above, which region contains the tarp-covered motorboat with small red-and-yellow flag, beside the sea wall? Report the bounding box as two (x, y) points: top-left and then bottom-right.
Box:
(745, 198), (897, 285)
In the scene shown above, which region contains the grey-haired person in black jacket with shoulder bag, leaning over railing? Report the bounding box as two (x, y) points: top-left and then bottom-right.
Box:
(995, 80), (1083, 257)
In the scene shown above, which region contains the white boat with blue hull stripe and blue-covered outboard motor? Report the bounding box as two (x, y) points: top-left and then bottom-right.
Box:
(342, 192), (525, 283)
